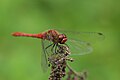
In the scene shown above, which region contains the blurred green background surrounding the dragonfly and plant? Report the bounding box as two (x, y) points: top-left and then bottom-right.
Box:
(0, 0), (120, 80)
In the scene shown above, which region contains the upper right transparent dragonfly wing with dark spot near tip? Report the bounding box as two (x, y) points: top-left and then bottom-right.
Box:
(58, 30), (105, 43)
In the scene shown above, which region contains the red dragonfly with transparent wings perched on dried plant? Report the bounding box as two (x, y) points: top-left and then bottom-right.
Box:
(12, 29), (104, 72)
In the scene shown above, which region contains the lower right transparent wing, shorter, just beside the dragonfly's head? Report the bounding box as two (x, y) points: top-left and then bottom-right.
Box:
(66, 40), (93, 55)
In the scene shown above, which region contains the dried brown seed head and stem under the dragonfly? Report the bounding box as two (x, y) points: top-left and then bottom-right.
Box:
(48, 45), (87, 80)
